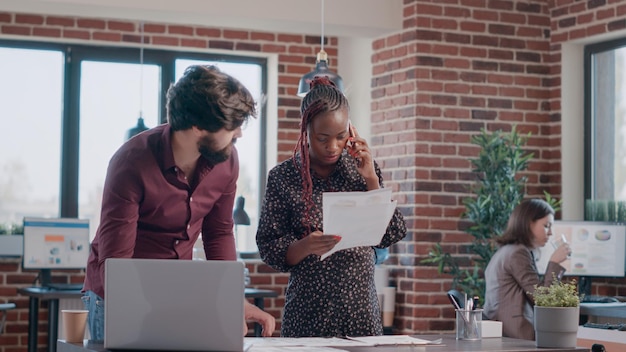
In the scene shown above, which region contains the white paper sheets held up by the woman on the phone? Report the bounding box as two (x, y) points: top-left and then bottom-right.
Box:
(321, 188), (397, 260)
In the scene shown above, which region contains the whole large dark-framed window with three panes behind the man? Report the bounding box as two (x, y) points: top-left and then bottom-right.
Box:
(0, 41), (267, 252)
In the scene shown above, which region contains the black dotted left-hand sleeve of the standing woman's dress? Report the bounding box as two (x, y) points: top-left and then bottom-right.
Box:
(256, 170), (298, 272)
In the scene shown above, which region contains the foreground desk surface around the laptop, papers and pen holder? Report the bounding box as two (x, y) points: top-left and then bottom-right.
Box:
(57, 334), (589, 352)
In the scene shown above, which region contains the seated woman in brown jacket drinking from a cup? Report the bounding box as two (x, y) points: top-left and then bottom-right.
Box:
(483, 199), (571, 340)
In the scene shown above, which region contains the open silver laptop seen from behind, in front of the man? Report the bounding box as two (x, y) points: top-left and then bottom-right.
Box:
(104, 259), (244, 352)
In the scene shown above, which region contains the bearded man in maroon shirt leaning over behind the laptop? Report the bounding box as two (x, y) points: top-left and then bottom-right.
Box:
(83, 66), (275, 340)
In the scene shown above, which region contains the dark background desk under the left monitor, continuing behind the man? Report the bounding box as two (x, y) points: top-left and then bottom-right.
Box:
(17, 287), (278, 352)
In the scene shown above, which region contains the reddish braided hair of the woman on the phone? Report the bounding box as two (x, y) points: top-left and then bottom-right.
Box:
(292, 76), (350, 234)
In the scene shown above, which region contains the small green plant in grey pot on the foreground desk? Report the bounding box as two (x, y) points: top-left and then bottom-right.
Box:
(530, 279), (580, 348)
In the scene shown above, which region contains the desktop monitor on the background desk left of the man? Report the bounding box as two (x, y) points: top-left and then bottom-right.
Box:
(22, 217), (89, 286)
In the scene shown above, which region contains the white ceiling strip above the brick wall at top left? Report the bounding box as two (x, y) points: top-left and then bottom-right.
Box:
(0, 0), (402, 38)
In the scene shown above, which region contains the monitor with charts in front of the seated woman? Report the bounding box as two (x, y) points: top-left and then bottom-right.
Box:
(535, 220), (626, 277)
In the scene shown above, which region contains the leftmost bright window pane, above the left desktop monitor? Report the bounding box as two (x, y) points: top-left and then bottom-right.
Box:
(0, 47), (64, 226)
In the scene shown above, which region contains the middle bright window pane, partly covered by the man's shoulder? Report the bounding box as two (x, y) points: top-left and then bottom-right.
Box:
(78, 60), (161, 238)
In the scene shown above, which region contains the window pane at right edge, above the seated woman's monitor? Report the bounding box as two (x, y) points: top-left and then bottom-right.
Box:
(584, 39), (626, 201)
